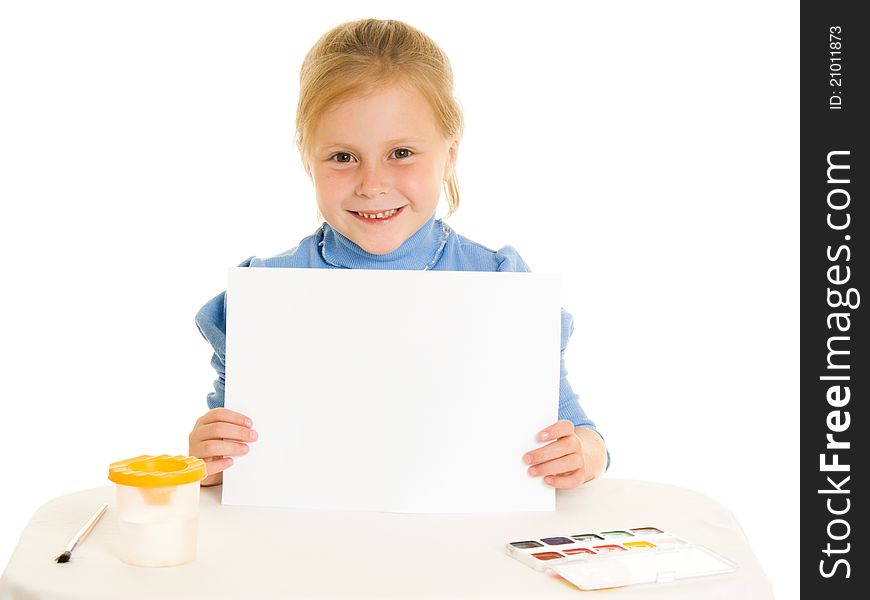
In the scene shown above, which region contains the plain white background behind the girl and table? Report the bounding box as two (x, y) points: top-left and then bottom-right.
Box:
(0, 0), (799, 598)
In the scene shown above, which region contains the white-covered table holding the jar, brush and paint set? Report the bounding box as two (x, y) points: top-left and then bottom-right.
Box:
(0, 477), (773, 600)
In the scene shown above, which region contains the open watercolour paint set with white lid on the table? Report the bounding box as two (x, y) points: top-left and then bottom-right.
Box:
(506, 527), (737, 590)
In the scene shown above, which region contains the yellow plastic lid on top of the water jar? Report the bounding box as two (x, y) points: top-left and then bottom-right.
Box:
(109, 454), (207, 487)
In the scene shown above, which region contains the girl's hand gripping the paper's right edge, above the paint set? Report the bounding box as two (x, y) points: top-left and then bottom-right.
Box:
(523, 419), (598, 489)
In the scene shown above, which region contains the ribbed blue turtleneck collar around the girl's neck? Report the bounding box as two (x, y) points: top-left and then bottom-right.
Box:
(319, 215), (450, 271)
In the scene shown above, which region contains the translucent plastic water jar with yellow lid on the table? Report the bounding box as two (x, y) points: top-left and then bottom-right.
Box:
(109, 454), (206, 567)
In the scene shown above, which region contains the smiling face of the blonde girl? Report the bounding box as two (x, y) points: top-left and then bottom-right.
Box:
(306, 84), (459, 254)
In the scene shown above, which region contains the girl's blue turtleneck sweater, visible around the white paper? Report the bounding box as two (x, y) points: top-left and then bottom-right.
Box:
(196, 216), (595, 429)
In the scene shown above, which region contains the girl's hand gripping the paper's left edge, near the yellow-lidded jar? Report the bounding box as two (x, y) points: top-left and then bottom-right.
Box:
(188, 408), (257, 486)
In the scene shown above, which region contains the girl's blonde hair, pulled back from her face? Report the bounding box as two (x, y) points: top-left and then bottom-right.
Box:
(296, 19), (463, 216)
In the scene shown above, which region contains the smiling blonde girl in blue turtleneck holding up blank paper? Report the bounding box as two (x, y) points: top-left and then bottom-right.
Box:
(189, 19), (609, 488)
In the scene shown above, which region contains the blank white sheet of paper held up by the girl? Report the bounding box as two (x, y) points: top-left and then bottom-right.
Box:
(222, 268), (561, 513)
